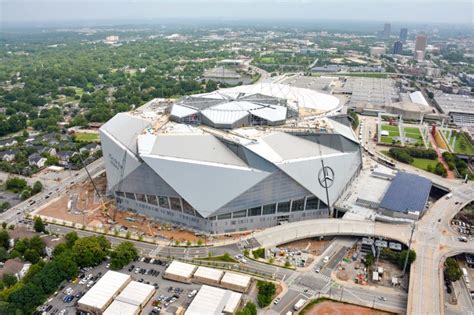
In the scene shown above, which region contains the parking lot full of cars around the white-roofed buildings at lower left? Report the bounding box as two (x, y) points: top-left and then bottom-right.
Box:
(39, 257), (201, 315)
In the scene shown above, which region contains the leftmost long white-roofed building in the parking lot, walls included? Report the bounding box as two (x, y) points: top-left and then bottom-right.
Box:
(77, 270), (132, 315)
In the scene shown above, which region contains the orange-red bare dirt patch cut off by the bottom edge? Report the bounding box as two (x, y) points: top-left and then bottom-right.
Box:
(304, 301), (391, 315)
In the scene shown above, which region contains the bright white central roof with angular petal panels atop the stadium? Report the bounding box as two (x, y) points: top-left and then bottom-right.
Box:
(170, 83), (340, 129)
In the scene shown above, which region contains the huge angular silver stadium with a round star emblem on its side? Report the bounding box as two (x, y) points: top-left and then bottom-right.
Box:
(100, 83), (362, 233)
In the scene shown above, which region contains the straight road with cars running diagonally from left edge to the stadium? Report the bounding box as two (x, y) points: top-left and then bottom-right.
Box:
(0, 158), (105, 224)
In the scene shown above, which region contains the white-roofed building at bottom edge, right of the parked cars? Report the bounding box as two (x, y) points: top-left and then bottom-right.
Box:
(184, 285), (242, 315)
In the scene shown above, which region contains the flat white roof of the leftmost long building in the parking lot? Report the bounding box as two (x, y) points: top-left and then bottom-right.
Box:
(79, 270), (130, 309)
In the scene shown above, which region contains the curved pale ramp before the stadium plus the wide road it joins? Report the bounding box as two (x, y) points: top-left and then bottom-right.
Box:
(253, 184), (474, 315)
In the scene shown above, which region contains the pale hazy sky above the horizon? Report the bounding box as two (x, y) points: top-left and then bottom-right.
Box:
(0, 0), (474, 25)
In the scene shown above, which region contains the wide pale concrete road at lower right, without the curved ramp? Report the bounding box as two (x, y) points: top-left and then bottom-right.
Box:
(407, 184), (474, 315)
